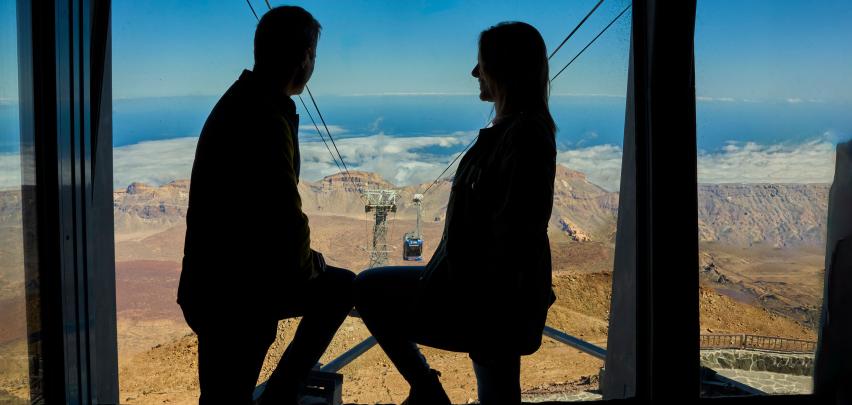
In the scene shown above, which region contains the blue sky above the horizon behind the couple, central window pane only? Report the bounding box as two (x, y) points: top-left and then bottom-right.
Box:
(113, 0), (629, 98)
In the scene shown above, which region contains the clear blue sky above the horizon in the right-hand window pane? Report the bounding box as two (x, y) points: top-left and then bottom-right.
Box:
(695, 0), (852, 101)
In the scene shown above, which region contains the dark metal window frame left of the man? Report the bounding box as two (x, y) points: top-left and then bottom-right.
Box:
(17, 0), (118, 403)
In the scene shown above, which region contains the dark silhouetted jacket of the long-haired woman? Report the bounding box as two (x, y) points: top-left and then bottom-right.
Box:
(420, 113), (556, 354)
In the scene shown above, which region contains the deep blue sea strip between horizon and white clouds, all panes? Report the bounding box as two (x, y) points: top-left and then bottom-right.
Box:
(0, 95), (852, 153)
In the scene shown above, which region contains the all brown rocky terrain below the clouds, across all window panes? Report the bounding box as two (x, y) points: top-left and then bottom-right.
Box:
(0, 166), (828, 403)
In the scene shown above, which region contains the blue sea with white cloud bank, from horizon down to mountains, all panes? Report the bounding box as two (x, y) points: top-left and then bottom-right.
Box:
(0, 95), (852, 190)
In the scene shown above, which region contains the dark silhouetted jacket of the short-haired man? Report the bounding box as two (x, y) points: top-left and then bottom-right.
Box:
(178, 70), (319, 318)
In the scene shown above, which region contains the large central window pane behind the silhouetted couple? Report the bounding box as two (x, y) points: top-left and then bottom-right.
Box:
(112, 0), (631, 403)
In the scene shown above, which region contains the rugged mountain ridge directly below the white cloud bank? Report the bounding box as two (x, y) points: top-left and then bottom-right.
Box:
(108, 165), (829, 247)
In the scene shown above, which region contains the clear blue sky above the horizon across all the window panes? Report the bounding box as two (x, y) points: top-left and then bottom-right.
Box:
(0, 0), (852, 101)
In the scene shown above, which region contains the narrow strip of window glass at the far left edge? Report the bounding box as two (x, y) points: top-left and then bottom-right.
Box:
(0, 0), (30, 404)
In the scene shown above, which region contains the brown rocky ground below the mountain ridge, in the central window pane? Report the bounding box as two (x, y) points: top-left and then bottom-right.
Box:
(111, 215), (611, 403)
